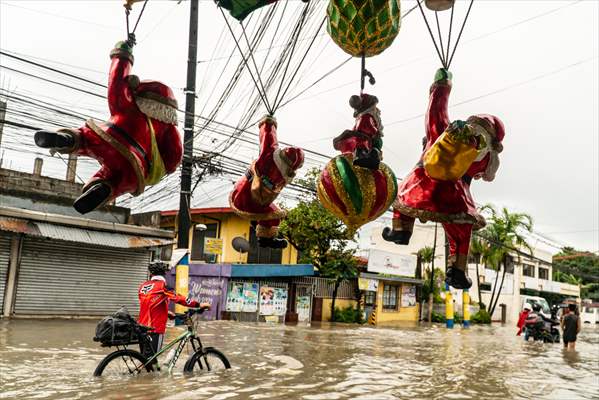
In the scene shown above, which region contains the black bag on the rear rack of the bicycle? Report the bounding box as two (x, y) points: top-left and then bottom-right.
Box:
(94, 306), (139, 346)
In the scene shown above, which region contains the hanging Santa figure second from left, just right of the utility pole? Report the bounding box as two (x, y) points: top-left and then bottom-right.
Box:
(229, 116), (304, 249)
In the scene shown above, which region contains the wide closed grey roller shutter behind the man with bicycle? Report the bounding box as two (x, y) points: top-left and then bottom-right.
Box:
(15, 237), (150, 316)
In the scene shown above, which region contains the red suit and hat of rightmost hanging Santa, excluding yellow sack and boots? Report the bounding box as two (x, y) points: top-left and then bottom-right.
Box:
(393, 69), (505, 276)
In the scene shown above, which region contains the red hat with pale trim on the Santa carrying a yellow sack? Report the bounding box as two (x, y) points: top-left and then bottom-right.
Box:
(466, 114), (505, 182)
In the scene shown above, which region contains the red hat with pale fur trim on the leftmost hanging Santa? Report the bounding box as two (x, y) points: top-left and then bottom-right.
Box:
(127, 75), (178, 125)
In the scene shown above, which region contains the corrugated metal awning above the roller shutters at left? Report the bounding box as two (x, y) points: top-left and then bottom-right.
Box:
(0, 216), (174, 249)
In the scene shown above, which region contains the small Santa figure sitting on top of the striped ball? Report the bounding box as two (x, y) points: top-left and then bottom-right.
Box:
(333, 93), (383, 170)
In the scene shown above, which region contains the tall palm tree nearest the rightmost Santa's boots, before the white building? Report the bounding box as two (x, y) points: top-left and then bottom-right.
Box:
(479, 205), (533, 315)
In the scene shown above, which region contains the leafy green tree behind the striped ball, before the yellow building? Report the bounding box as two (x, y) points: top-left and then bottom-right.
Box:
(280, 168), (358, 316)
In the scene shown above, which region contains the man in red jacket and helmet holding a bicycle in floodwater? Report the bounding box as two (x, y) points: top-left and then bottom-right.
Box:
(137, 262), (210, 355)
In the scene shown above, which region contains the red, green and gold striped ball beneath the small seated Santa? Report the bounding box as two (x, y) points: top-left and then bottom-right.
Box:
(317, 155), (397, 231)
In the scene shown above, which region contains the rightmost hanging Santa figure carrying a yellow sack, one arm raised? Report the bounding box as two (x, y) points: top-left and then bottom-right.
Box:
(383, 69), (505, 289)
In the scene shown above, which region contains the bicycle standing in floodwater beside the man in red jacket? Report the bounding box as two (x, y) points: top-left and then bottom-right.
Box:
(94, 308), (231, 376)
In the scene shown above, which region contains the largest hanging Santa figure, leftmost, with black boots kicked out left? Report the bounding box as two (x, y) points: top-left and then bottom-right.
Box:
(35, 35), (182, 214)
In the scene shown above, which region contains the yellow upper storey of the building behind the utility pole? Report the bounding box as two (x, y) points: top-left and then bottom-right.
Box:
(160, 207), (297, 264)
